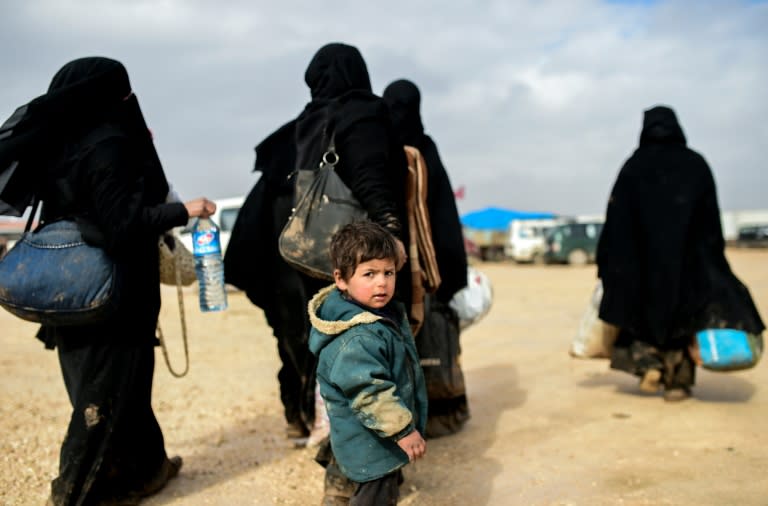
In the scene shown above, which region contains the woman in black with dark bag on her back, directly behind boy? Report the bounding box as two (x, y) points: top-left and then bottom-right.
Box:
(224, 43), (410, 444)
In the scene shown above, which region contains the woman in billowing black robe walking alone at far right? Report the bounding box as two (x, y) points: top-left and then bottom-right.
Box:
(597, 106), (765, 401)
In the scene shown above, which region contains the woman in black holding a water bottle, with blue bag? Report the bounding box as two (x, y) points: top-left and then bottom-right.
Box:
(0, 57), (216, 506)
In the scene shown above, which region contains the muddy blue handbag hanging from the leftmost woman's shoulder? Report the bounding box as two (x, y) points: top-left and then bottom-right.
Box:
(0, 209), (119, 326)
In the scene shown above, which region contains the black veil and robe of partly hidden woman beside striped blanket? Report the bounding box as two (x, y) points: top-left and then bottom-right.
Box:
(382, 79), (467, 302)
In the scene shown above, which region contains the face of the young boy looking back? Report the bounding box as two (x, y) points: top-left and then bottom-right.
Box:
(333, 258), (397, 309)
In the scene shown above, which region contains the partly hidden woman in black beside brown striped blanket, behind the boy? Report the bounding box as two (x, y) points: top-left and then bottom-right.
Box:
(382, 79), (470, 438)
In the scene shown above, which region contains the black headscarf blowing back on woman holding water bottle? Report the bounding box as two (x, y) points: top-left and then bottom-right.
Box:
(0, 57), (168, 215)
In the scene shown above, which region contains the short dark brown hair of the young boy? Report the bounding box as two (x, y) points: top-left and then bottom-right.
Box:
(329, 221), (398, 280)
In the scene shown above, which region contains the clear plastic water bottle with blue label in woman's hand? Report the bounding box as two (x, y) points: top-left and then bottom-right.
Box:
(192, 218), (227, 311)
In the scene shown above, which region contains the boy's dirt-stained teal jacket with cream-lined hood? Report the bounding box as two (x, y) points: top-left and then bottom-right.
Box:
(309, 286), (427, 483)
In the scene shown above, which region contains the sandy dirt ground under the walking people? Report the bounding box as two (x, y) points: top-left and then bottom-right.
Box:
(0, 250), (768, 506)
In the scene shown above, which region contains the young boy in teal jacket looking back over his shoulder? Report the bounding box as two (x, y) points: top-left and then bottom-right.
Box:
(309, 221), (427, 505)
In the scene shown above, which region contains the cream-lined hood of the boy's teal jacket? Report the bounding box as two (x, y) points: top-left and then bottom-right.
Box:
(307, 285), (382, 355)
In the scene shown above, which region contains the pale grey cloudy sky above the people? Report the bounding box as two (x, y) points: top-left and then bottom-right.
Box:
(0, 0), (768, 214)
